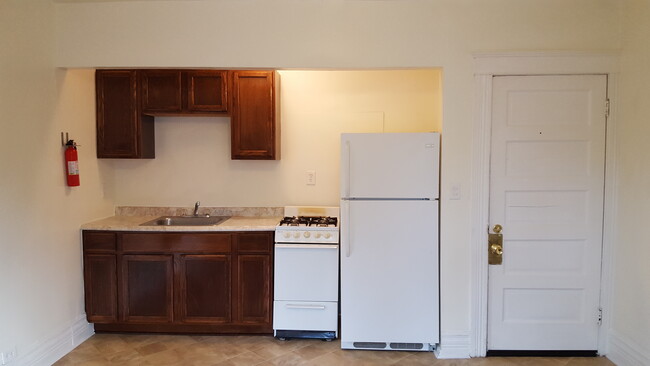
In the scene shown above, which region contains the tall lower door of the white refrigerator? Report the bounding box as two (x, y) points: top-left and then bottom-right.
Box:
(341, 200), (440, 351)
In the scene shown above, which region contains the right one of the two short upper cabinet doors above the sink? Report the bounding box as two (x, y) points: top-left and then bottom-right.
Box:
(186, 70), (228, 112)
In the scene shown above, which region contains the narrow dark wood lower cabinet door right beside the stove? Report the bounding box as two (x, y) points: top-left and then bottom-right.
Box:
(233, 255), (272, 324)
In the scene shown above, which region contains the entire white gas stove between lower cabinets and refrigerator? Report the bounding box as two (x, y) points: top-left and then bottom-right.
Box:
(273, 206), (339, 340)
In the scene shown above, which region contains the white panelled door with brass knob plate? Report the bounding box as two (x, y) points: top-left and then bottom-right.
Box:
(486, 75), (607, 350)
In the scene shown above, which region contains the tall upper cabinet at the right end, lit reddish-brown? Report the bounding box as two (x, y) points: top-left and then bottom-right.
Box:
(230, 70), (280, 160)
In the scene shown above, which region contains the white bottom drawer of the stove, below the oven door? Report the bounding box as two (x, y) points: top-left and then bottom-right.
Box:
(273, 301), (338, 331)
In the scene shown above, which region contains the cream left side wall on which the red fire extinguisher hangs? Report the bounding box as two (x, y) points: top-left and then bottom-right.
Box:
(0, 0), (112, 364)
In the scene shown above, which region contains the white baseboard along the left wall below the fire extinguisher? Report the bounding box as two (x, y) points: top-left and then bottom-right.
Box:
(16, 314), (95, 366)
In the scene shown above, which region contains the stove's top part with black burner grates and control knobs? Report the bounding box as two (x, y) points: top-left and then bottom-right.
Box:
(275, 206), (339, 244)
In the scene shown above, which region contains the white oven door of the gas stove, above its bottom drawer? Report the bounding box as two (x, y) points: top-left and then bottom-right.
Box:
(273, 243), (339, 301)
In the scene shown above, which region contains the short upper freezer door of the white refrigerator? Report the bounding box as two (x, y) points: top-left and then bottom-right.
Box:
(341, 133), (440, 199)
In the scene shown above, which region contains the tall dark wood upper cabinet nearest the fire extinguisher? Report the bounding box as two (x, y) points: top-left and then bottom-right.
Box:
(95, 70), (155, 159)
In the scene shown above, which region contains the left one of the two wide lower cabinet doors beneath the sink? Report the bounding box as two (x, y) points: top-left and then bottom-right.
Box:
(120, 255), (173, 323)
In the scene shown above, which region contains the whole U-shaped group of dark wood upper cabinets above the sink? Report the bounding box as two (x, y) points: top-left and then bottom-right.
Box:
(95, 69), (280, 160)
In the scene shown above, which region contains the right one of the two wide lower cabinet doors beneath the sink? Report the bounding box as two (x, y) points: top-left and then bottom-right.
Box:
(176, 255), (232, 324)
